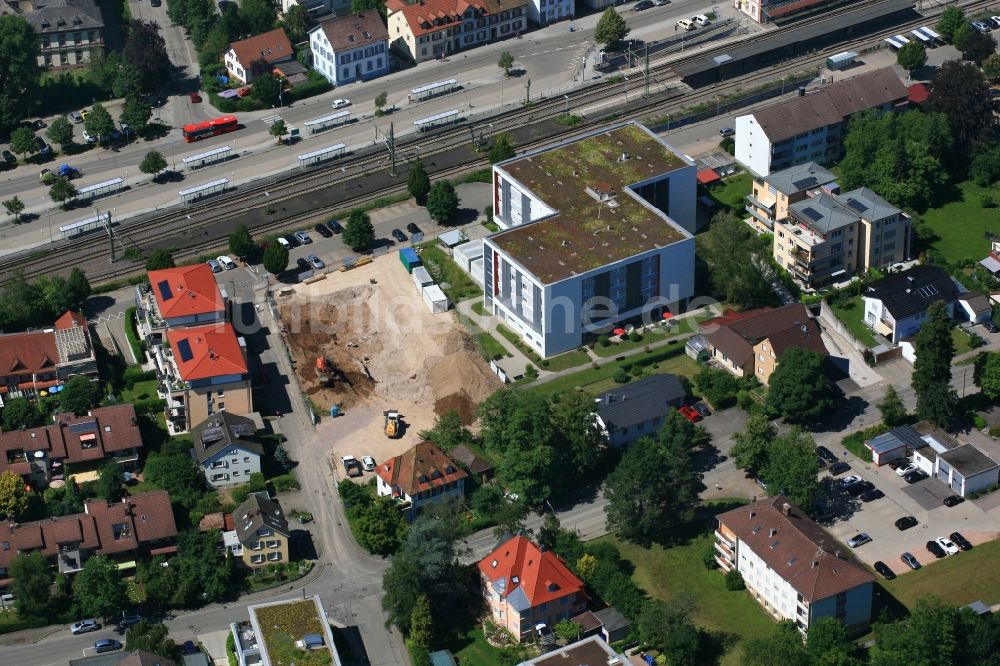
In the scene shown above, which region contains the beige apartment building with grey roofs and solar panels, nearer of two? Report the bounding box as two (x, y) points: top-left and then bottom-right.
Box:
(773, 187), (911, 287)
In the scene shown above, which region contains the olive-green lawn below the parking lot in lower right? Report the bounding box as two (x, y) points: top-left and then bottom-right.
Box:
(879, 541), (1000, 608)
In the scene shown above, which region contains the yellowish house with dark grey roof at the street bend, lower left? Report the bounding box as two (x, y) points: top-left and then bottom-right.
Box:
(222, 492), (291, 573)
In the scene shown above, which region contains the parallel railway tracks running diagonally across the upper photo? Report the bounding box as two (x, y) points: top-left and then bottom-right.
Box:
(0, 0), (989, 284)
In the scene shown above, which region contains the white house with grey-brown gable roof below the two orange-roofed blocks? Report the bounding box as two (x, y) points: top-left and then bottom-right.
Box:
(191, 411), (264, 488)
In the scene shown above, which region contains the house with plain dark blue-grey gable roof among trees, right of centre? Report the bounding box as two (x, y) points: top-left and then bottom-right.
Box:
(594, 373), (687, 447)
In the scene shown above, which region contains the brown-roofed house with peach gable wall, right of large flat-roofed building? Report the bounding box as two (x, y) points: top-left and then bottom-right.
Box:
(705, 303), (827, 385)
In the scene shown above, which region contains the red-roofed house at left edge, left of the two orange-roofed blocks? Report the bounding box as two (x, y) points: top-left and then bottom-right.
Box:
(0, 310), (97, 405)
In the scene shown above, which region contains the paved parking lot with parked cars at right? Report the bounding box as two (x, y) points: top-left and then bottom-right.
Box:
(820, 460), (1000, 575)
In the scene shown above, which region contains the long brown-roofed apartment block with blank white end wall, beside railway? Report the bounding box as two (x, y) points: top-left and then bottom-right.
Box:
(735, 67), (908, 178)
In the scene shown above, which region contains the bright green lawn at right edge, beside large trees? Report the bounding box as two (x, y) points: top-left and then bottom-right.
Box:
(921, 181), (1000, 263)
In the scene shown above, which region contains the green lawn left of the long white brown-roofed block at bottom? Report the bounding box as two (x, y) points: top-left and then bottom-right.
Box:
(598, 534), (774, 666)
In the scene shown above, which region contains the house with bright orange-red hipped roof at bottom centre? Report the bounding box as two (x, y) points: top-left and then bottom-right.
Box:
(477, 536), (587, 641)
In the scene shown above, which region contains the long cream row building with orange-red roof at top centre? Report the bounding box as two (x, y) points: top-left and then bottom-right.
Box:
(385, 0), (528, 62)
